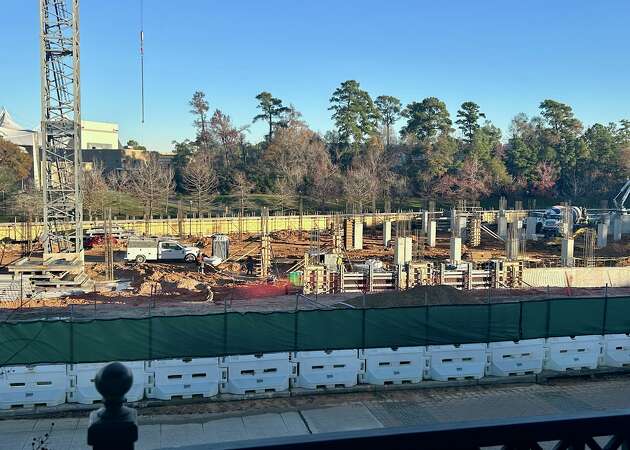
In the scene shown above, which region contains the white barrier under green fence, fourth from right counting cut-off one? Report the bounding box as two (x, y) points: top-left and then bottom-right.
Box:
(425, 344), (487, 381)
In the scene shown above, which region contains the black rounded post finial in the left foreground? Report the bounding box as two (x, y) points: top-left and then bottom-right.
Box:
(88, 362), (138, 450)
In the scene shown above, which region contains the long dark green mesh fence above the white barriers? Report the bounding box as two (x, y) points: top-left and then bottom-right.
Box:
(0, 297), (630, 366)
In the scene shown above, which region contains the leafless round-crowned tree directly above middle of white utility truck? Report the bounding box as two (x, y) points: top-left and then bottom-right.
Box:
(126, 154), (174, 224)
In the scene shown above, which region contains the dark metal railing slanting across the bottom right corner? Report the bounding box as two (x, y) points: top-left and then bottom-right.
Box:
(159, 410), (630, 450)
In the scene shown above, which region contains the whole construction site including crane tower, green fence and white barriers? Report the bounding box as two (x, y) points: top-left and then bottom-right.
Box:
(0, 0), (630, 446)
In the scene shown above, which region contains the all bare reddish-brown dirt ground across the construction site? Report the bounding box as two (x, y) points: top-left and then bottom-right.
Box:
(0, 229), (630, 318)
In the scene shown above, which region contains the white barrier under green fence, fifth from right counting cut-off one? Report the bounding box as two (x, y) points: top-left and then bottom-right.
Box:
(359, 347), (425, 385)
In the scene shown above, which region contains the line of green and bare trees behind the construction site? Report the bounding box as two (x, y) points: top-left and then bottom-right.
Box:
(0, 80), (630, 222)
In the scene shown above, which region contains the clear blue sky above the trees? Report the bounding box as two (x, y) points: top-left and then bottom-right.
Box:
(0, 0), (630, 151)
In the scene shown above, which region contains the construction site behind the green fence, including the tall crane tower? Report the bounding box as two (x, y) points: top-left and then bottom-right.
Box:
(0, 0), (630, 317)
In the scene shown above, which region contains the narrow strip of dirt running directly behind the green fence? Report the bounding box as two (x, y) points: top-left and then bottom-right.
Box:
(0, 286), (630, 321)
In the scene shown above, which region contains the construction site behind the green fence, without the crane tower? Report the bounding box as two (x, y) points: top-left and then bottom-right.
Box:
(0, 197), (630, 314)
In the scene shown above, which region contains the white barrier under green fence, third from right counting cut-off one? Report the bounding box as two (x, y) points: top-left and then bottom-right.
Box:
(486, 339), (545, 377)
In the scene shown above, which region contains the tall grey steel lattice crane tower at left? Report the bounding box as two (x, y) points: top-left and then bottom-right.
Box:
(40, 0), (83, 254)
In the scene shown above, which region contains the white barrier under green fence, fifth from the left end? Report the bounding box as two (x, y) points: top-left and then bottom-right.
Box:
(291, 350), (365, 389)
